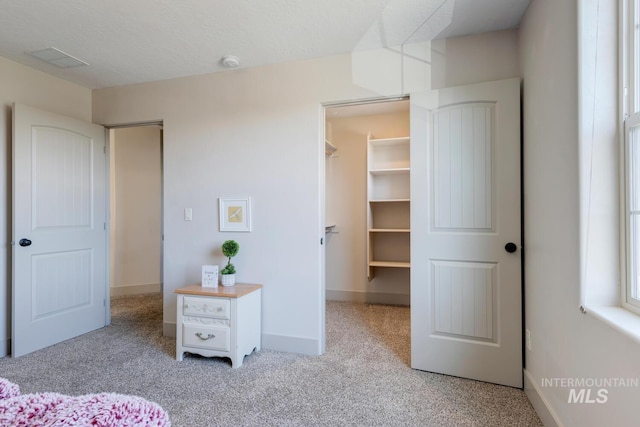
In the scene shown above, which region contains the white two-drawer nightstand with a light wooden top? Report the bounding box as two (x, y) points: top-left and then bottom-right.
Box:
(175, 283), (262, 368)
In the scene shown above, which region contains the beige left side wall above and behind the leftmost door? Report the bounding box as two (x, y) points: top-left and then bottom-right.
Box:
(0, 57), (91, 356)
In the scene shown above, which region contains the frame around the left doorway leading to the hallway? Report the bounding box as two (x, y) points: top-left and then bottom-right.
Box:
(102, 120), (165, 325)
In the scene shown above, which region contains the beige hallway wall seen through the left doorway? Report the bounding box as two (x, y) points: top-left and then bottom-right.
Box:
(110, 126), (162, 295)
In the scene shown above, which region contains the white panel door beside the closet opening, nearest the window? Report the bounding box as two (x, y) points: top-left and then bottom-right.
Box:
(411, 79), (522, 387)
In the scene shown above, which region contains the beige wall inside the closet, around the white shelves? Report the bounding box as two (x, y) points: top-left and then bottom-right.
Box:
(325, 101), (410, 305)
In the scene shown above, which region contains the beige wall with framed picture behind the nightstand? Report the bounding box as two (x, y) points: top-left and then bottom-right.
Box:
(93, 31), (517, 354)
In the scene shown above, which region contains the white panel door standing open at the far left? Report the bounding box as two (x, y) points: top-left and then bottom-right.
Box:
(11, 104), (107, 357)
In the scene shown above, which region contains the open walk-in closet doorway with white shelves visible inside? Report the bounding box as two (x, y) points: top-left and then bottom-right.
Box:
(324, 98), (411, 364)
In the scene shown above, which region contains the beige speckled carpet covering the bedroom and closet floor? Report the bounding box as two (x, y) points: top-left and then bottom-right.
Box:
(0, 294), (542, 427)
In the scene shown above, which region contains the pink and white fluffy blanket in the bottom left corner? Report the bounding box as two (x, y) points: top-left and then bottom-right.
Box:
(0, 378), (171, 427)
